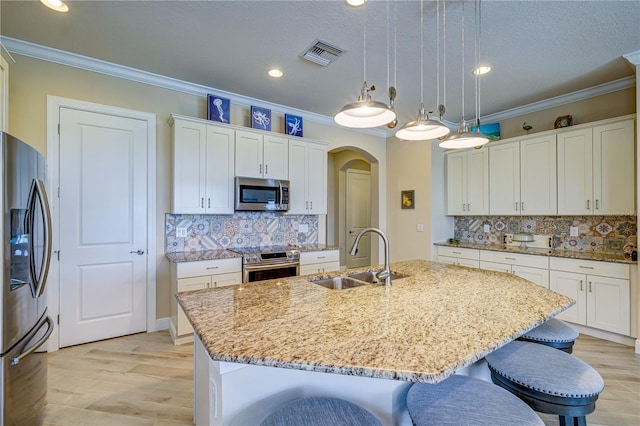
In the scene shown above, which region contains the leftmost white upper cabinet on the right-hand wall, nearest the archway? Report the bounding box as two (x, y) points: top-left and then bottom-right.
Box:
(446, 149), (489, 216)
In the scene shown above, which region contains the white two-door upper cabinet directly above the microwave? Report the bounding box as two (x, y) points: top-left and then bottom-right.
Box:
(235, 130), (289, 180)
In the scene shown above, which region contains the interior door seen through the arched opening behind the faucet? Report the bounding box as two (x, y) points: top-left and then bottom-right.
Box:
(345, 169), (371, 268)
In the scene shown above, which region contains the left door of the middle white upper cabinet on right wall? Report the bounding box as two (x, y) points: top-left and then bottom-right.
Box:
(489, 141), (521, 215)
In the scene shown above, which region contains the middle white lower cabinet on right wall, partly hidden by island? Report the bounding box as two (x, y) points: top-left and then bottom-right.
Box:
(480, 250), (549, 288)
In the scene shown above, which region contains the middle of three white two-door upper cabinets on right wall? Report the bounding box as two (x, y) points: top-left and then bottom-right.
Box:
(489, 135), (557, 215)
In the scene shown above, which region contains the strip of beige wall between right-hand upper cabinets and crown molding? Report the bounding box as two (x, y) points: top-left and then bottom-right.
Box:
(500, 87), (636, 139)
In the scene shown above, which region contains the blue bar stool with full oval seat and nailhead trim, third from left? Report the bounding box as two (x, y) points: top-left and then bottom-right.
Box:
(486, 341), (604, 426)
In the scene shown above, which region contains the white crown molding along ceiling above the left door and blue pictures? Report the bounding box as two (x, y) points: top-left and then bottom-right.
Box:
(0, 36), (386, 138)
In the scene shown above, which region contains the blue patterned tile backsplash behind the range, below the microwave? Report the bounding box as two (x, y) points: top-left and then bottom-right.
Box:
(164, 212), (318, 253)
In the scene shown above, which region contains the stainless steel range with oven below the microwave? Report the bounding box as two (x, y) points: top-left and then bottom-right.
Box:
(230, 246), (300, 283)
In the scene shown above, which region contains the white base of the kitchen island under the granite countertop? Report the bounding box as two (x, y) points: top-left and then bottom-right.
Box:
(194, 336), (491, 426)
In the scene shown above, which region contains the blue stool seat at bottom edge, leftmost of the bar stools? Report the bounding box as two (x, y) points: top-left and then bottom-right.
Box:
(260, 397), (382, 426)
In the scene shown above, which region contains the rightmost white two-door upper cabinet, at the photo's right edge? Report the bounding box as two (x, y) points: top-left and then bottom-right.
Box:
(558, 119), (636, 215)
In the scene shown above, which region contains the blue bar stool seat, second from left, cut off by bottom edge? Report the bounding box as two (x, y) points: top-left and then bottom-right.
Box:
(407, 375), (544, 426)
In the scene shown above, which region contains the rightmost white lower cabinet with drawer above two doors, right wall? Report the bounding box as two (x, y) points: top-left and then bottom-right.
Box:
(549, 258), (631, 335)
